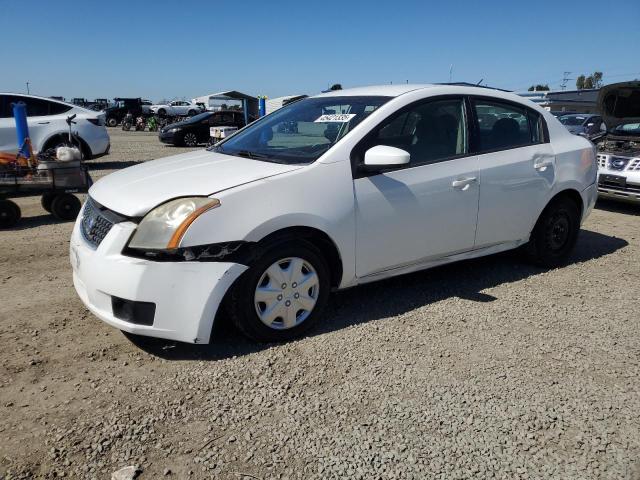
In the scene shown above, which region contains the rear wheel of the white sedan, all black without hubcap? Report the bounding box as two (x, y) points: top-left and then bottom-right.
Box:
(524, 197), (580, 268)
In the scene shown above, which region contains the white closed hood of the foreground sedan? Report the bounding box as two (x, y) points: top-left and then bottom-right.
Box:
(89, 150), (302, 217)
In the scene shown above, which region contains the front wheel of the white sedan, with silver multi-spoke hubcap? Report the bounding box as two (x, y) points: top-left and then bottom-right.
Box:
(229, 242), (331, 342)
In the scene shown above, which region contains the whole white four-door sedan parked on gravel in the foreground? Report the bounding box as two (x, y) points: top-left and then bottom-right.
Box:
(70, 85), (597, 343)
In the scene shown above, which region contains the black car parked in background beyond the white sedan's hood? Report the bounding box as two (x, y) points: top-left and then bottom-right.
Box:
(158, 110), (254, 147)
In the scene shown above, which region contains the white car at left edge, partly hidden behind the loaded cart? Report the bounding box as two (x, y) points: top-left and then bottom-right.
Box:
(0, 93), (109, 159)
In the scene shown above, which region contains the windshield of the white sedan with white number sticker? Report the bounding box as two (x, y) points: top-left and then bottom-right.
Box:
(211, 96), (390, 163)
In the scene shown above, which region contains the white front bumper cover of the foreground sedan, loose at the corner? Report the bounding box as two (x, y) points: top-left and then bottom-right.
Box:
(70, 210), (247, 343)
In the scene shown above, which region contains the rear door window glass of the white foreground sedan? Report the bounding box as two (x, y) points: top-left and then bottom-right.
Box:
(472, 99), (544, 152)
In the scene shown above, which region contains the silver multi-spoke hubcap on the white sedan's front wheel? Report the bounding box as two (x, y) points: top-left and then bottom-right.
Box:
(254, 257), (320, 330)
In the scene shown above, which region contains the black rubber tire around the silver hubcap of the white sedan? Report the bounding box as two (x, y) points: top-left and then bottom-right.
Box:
(227, 240), (331, 342)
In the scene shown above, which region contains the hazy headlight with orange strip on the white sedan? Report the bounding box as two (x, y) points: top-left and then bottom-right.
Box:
(129, 197), (220, 250)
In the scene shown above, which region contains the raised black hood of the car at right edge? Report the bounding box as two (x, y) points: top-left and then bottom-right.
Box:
(598, 81), (640, 130)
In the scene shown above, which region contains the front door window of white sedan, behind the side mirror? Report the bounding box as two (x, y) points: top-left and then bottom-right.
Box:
(360, 98), (468, 165)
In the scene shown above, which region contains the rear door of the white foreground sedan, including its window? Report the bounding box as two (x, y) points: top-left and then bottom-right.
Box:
(471, 98), (556, 248)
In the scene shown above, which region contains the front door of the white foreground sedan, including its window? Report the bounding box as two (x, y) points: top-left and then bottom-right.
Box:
(354, 98), (479, 278)
